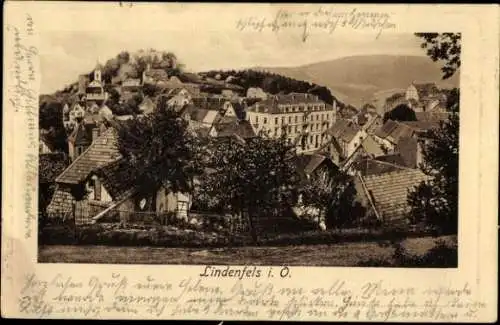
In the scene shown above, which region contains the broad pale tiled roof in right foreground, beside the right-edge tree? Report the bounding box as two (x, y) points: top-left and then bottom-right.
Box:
(359, 169), (427, 222)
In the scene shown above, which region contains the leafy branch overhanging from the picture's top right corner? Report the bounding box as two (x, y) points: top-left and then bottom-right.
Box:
(415, 33), (462, 79)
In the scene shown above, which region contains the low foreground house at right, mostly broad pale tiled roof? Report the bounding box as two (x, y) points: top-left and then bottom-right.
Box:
(355, 168), (428, 226)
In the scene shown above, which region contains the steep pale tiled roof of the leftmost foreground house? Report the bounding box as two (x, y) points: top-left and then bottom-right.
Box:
(56, 127), (121, 184)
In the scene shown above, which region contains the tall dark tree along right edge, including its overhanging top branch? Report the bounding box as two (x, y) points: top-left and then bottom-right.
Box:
(408, 34), (460, 233)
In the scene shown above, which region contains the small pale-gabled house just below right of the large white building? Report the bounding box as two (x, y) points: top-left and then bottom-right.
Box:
(326, 119), (367, 166)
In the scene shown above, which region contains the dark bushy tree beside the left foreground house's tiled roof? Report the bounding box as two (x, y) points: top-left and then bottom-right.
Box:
(118, 109), (202, 197)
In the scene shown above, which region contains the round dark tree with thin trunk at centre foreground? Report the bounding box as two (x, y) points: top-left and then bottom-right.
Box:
(199, 133), (298, 243)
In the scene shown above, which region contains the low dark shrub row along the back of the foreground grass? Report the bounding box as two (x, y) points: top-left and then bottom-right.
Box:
(39, 223), (438, 247)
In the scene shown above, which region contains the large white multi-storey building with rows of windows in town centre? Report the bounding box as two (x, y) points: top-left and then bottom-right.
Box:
(247, 93), (337, 153)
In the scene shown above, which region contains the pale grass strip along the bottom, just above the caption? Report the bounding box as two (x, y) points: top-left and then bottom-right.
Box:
(38, 237), (452, 266)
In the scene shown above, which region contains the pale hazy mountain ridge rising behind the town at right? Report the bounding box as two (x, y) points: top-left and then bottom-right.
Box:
(251, 55), (460, 108)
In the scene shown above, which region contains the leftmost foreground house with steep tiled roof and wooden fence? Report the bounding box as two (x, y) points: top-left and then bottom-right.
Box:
(47, 125), (189, 224)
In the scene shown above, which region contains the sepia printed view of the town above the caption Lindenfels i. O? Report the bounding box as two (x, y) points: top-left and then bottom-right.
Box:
(38, 17), (461, 268)
